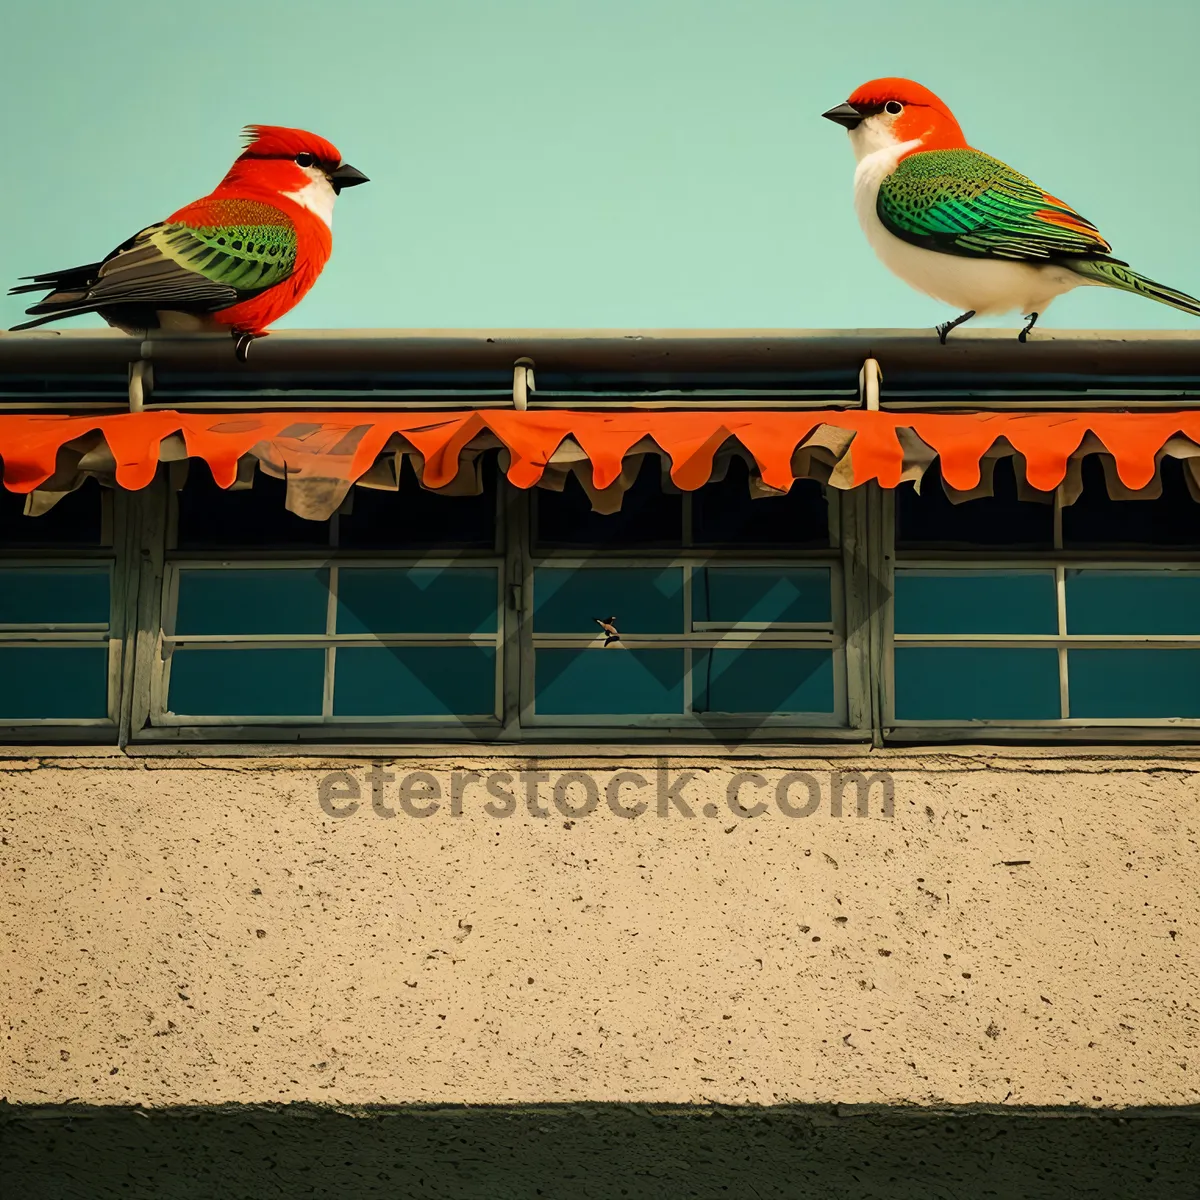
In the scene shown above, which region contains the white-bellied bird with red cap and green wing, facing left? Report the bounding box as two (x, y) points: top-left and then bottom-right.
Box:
(823, 78), (1200, 342)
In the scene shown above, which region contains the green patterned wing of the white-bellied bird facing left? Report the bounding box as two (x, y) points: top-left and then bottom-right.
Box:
(876, 150), (1111, 262)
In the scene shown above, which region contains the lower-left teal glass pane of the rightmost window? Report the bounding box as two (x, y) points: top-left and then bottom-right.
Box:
(895, 646), (1062, 721)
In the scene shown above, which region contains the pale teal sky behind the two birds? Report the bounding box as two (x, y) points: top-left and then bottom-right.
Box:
(0, 0), (1200, 329)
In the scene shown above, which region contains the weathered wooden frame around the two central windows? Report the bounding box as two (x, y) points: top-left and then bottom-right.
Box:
(124, 458), (872, 744)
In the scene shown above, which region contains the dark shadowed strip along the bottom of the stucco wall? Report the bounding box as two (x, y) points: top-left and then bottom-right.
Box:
(0, 1103), (1200, 1200)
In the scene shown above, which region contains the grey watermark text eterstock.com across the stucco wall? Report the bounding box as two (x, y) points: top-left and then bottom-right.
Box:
(317, 758), (895, 821)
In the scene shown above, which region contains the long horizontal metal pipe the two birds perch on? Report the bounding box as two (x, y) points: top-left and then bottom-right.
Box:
(0, 330), (1200, 386)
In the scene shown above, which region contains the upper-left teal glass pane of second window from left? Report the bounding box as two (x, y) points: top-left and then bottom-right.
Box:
(175, 568), (329, 634)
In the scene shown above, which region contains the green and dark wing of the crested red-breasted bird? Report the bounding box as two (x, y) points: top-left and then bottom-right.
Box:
(72, 199), (296, 308)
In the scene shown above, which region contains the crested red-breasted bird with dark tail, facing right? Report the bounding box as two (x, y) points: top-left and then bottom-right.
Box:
(10, 125), (367, 360)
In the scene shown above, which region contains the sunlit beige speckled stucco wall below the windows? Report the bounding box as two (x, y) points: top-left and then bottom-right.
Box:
(0, 751), (1200, 1108)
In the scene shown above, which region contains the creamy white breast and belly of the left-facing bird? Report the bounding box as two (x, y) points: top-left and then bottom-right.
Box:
(854, 140), (1086, 316)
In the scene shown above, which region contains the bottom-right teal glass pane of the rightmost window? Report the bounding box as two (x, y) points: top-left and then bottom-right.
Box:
(1067, 648), (1200, 719)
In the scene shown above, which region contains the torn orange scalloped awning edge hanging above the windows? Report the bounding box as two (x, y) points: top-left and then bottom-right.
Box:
(0, 409), (1200, 520)
